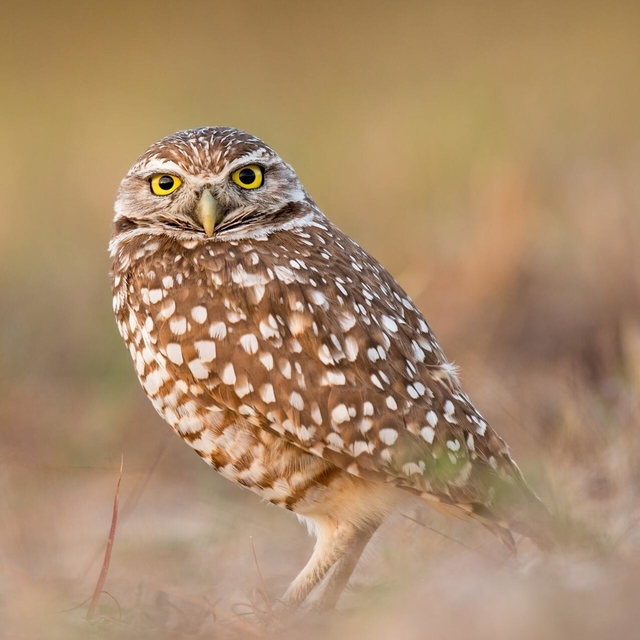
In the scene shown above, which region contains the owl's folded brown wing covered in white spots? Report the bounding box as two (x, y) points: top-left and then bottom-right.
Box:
(140, 227), (536, 516)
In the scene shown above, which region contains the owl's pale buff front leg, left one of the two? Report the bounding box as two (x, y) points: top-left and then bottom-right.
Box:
(281, 521), (373, 610)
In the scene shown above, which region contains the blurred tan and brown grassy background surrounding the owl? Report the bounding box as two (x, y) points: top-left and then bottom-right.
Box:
(0, 0), (640, 639)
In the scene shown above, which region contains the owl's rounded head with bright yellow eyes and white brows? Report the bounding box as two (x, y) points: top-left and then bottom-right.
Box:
(114, 127), (312, 240)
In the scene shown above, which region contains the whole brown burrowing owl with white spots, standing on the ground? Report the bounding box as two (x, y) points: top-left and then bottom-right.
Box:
(110, 127), (543, 606)
